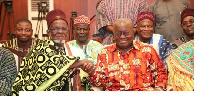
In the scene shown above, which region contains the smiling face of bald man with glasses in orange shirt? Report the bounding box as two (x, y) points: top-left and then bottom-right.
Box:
(113, 19), (134, 51)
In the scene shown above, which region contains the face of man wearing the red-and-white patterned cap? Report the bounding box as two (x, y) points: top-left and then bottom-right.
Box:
(74, 24), (90, 43)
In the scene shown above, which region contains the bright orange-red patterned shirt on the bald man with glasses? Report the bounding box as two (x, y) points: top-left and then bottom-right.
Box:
(89, 40), (167, 91)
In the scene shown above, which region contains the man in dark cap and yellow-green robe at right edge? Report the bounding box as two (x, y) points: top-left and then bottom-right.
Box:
(167, 8), (194, 91)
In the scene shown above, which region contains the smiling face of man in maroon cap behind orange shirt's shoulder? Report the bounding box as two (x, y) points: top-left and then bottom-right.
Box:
(137, 19), (154, 43)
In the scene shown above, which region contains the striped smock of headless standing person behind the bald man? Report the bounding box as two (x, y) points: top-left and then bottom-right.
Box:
(93, 0), (147, 45)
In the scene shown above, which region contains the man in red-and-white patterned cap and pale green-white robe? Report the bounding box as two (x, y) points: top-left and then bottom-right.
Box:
(67, 15), (103, 90)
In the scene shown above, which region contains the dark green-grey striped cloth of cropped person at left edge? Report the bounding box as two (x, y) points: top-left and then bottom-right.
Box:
(0, 47), (17, 96)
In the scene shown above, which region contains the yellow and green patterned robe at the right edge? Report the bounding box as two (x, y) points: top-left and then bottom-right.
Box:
(167, 40), (194, 91)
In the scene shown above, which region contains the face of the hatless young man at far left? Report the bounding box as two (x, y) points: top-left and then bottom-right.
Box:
(15, 21), (33, 42)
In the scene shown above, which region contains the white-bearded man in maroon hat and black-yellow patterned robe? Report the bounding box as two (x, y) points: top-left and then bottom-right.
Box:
(13, 9), (93, 96)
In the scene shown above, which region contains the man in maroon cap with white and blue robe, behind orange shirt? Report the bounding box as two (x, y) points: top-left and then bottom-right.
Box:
(135, 11), (172, 68)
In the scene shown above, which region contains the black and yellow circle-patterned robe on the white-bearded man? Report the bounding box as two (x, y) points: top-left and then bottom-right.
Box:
(12, 40), (79, 96)
